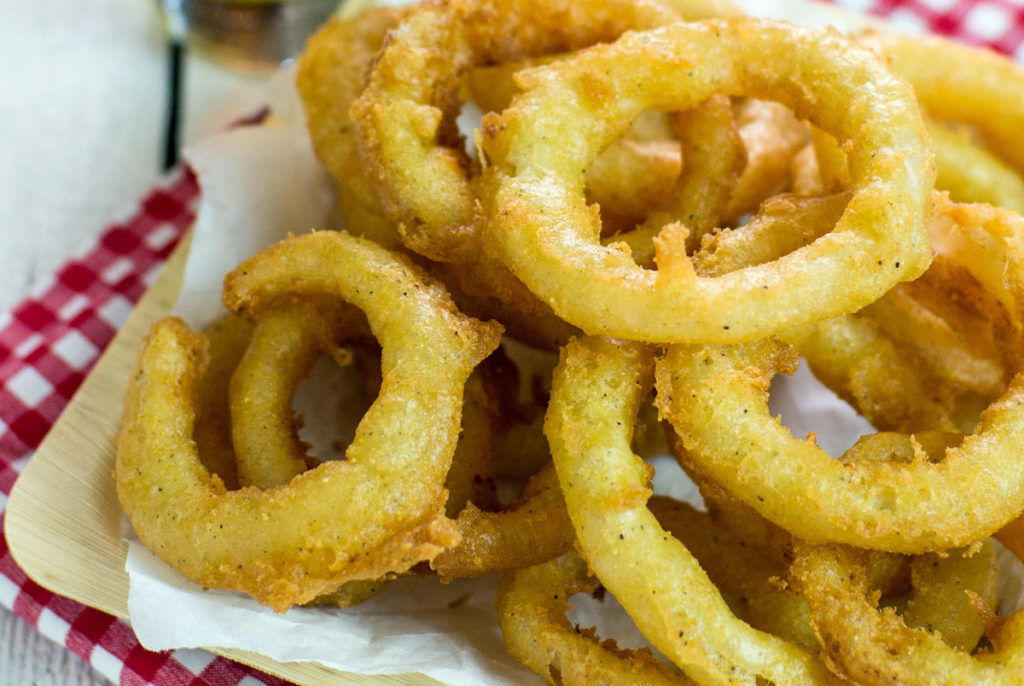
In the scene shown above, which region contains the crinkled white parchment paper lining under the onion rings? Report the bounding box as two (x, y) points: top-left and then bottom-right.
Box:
(127, 0), (1021, 686)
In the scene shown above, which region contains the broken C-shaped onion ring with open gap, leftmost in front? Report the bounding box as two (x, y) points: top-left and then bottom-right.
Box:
(116, 232), (500, 611)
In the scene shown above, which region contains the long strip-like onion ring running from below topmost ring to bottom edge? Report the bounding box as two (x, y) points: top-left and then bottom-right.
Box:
(545, 337), (831, 684)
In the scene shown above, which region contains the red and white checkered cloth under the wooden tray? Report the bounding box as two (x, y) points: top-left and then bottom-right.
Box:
(0, 0), (1024, 686)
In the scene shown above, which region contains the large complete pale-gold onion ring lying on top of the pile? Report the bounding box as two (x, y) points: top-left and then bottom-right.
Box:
(478, 19), (935, 342)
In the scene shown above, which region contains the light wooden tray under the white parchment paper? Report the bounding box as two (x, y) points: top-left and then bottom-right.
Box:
(5, 237), (439, 686)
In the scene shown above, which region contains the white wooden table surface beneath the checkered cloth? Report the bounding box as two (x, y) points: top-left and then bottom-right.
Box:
(0, 0), (270, 686)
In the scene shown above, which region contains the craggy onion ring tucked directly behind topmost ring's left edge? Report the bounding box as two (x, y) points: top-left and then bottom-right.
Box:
(351, 0), (692, 317)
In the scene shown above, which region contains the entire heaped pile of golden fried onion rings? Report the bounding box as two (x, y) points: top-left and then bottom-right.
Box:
(117, 0), (1024, 686)
